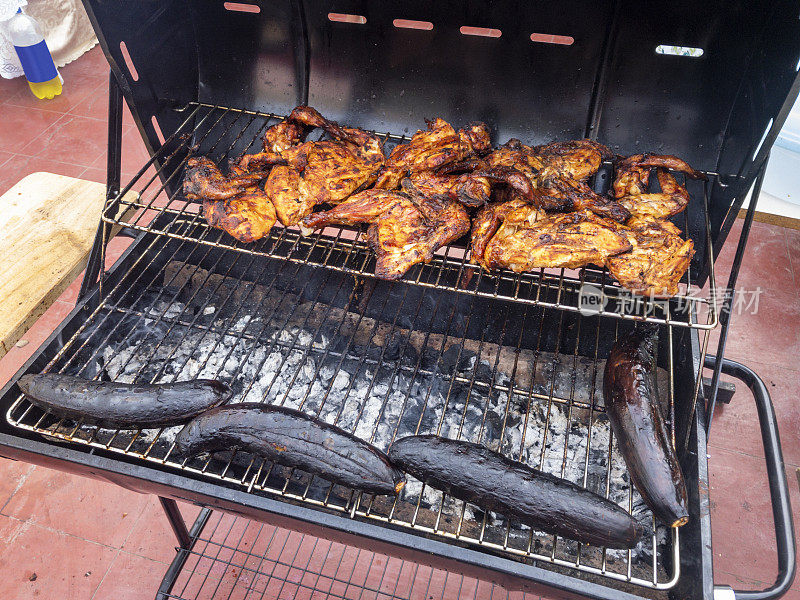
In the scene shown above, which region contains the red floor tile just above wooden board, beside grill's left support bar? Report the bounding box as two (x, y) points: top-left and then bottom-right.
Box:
(20, 115), (108, 169)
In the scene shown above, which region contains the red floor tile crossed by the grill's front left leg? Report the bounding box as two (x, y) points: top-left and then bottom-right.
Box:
(123, 496), (200, 563)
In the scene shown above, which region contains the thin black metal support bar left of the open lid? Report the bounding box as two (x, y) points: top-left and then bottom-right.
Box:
(78, 71), (122, 300)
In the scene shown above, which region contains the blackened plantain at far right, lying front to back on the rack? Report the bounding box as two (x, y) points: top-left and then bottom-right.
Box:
(603, 331), (689, 527)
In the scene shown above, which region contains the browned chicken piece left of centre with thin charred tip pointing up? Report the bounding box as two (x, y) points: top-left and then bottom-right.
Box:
(265, 106), (385, 226)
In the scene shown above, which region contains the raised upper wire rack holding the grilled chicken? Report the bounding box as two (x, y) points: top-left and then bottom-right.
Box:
(102, 103), (718, 330)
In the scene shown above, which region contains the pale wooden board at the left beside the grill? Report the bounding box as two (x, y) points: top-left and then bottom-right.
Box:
(0, 173), (135, 357)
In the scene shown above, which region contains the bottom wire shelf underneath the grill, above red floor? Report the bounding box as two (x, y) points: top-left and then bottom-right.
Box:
(157, 513), (534, 600)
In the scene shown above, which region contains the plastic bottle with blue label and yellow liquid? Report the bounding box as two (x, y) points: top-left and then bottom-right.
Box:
(5, 8), (64, 99)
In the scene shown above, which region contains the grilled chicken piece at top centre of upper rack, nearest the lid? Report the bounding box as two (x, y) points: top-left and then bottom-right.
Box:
(375, 119), (492, 190)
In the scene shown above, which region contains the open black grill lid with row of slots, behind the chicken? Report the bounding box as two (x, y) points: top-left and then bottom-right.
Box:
(85, 0), (800, 247)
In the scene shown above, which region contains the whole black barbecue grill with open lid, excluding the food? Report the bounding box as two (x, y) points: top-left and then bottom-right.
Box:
(0, 0), (800, 598)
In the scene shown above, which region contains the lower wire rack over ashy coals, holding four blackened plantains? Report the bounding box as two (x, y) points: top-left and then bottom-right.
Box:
(7, 236), (680, 589)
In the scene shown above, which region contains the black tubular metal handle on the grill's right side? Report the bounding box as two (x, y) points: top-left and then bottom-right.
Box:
(705, 355), (796, 600)
